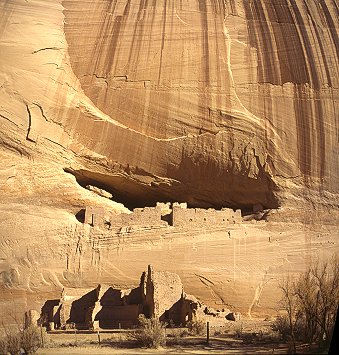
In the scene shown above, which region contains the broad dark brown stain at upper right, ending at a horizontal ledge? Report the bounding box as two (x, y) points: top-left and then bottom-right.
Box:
(243, 0), (321, 89)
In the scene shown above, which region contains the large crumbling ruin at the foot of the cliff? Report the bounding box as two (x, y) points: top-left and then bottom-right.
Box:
(38, 265), (231, 330)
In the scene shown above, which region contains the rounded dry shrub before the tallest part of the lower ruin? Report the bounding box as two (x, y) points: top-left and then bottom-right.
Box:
(131, 314), (166, 349)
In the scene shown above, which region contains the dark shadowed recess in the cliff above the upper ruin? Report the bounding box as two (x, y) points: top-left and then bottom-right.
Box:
(64, 158), (279, 211)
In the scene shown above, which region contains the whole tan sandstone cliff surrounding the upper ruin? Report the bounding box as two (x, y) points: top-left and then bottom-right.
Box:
(0, 0), (339, 328)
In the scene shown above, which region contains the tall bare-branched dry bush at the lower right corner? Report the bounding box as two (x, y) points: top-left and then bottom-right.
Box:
(273, 257), (339, 350)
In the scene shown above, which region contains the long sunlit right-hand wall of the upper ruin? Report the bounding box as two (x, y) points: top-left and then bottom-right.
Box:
(172, 204), (242, 228)
